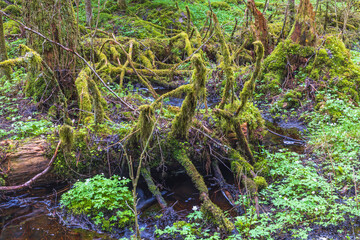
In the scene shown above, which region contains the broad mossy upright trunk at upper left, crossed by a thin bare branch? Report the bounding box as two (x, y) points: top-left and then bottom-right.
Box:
(22, 0), (79, 101)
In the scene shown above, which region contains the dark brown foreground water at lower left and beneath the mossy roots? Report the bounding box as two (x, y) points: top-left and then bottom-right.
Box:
(0, 176), (232, 240)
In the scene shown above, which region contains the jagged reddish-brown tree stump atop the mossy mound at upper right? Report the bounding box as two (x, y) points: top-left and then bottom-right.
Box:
(290, 0), (317, 46)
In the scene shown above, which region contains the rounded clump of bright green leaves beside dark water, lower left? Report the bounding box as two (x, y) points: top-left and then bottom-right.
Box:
(60, 175), (134, 231)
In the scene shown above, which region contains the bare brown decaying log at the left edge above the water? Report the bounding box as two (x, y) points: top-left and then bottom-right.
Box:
(0, 139), (61, 191)
